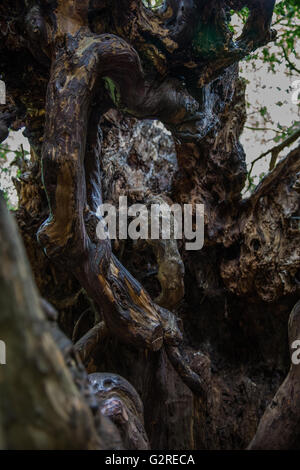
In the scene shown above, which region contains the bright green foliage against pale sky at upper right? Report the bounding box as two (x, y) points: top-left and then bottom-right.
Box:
(241, 0), (300, 191)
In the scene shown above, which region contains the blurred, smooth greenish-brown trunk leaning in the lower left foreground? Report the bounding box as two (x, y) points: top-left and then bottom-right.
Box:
(0, 194), (103, 449)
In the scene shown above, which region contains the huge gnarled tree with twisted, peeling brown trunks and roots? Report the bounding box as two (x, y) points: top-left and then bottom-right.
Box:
(0, 0), (300, 449)
